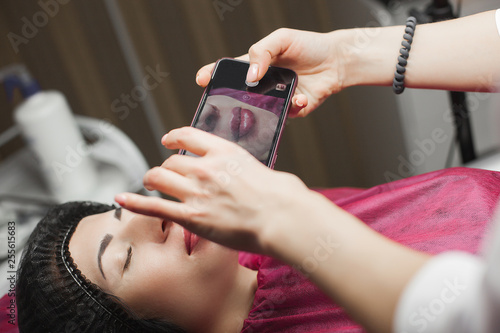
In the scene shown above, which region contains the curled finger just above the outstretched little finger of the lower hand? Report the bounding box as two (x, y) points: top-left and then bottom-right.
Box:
(143, 167), (197, 200)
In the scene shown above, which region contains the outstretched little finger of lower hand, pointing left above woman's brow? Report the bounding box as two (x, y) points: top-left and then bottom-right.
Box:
(115, 193), (197, 226)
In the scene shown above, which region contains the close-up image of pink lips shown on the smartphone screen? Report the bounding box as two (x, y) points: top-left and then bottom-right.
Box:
(196, 92), (282, 161)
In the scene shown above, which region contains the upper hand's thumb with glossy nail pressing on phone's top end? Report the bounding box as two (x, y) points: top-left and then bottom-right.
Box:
(246, 29), (292, 82)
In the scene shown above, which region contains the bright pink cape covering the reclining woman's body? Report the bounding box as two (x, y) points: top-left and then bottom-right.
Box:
(240, 168), (500, 333)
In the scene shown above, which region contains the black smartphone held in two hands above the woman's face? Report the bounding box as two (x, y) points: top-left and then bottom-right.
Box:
(187, 58), (297, 168)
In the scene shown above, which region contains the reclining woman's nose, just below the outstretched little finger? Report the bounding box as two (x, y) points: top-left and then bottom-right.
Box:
(118, 210), (168, 243)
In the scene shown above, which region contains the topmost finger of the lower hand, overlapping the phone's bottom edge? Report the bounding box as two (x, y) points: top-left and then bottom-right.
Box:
(162, 126), (238, 156)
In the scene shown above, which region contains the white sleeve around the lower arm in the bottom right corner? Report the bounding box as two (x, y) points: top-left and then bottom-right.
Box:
(394, 211), (500, 333)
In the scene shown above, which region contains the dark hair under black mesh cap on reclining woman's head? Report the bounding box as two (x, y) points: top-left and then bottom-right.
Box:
(16, 202), (188, 333)
